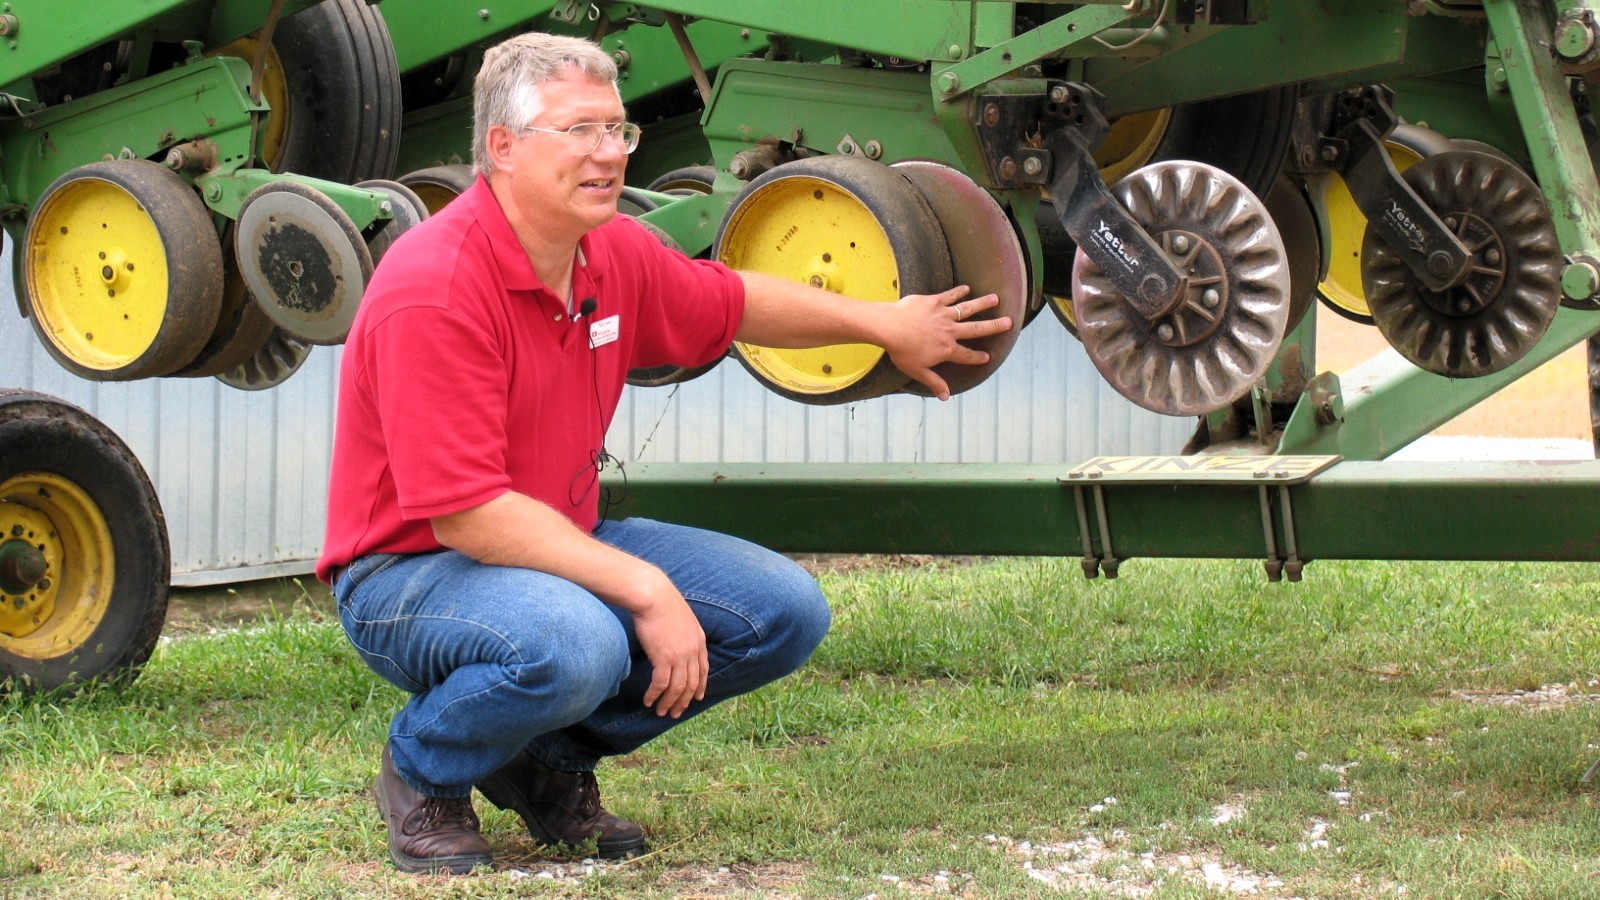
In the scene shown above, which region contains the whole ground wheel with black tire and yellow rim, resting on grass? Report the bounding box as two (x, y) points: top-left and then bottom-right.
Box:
(0, 391), (171, 690)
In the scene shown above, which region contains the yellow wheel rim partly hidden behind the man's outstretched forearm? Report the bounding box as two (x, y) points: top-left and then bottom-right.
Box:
(720, 175), (901, 394)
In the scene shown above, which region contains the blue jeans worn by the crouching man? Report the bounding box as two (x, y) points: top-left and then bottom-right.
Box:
(334, 519), (829, 798)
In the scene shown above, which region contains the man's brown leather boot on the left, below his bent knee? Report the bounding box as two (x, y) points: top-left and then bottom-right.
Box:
(373, 745), (494, 874)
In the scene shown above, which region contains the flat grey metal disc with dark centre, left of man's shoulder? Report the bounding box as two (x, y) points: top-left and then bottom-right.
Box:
(234, 181), (373, 344)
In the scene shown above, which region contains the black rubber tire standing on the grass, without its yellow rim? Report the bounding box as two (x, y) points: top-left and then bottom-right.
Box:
(0, 391), (171, 692)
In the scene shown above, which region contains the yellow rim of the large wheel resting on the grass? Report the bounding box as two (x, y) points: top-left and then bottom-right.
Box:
(0, 472), (117, 660)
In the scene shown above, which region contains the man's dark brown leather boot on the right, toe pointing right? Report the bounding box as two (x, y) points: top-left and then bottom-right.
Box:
(474, 749), (645, 860)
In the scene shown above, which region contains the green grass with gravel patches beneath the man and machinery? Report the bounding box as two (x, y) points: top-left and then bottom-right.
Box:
(0, 559), (1600, 898)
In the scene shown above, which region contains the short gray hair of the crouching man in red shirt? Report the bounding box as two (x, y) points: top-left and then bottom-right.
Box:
(472, 32), (616, 175)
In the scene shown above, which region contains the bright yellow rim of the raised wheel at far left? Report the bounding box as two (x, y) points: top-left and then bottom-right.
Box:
(27, 178), (170, 370)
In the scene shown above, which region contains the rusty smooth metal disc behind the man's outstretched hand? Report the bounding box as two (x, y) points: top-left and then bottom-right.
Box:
(890, 160), (1030, 397)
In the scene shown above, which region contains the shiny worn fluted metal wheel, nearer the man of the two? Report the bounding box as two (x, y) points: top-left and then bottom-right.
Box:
(1072, 162), (1290, 415)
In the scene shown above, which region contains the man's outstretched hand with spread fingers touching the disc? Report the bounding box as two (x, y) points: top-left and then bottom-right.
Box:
(883, 285), (1011, 400)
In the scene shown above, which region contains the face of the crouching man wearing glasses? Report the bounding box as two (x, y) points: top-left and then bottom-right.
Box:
(506, 70), (627, 239)
